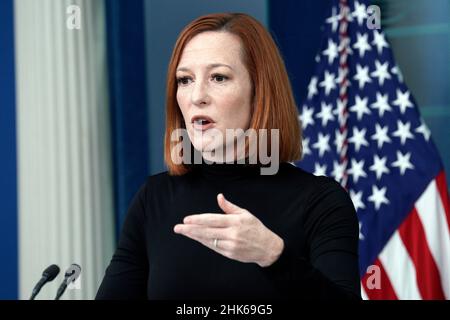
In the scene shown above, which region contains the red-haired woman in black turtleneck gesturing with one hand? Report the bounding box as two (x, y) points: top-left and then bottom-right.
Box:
(97, 14), (360, 299)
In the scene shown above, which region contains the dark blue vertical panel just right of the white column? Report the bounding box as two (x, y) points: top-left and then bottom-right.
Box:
(105, 0), (148, 234)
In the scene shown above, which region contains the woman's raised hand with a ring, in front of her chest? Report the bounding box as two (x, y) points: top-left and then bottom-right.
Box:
(174, 193), (284, 267)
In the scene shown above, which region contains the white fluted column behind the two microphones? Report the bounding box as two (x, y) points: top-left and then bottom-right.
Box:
(15, 0), (114, 299)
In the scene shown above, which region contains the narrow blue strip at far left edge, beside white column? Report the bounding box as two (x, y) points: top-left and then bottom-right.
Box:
(0, 0), (18, 299)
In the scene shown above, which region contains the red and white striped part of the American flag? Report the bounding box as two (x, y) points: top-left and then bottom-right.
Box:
(362, 171), (450, 300)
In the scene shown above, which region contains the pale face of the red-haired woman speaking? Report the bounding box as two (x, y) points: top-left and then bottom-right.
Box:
(176, 31), (252, 161)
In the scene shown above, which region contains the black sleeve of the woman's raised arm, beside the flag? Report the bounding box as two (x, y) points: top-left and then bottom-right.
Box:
(263, 177), (361, 299)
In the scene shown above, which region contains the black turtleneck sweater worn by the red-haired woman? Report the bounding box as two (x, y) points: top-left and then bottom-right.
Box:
(96, 163), (360, 299)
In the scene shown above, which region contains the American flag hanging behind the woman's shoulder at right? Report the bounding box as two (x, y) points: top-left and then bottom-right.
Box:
(296, 0), (450, 299)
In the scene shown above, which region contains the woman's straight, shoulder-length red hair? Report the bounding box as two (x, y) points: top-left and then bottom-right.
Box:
(164, 13), (302, 175)
